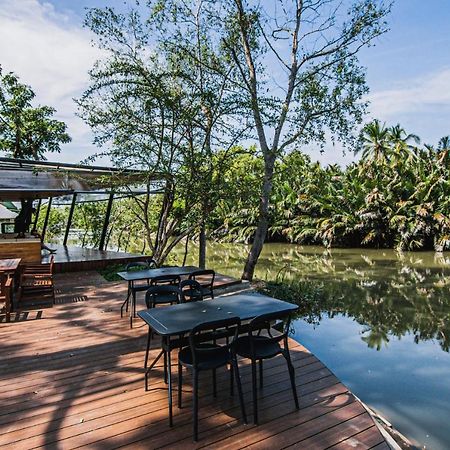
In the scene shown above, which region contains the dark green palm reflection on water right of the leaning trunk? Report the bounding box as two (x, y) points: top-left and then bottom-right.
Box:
(258, 250), (450, 352)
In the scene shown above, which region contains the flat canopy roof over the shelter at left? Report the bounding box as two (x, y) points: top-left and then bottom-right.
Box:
(0, 158), (159, 201)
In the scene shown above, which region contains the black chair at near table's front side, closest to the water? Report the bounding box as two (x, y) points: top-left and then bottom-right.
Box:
(232, 313), (299, 425)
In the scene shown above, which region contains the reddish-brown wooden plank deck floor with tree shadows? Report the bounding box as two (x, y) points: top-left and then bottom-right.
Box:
(0, 272), (389, 450)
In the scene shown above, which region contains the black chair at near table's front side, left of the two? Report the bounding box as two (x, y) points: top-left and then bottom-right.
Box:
(178, 317), (247, 441)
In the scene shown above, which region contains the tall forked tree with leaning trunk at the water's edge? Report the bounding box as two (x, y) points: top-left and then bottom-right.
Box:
(219, 0), (390, 280)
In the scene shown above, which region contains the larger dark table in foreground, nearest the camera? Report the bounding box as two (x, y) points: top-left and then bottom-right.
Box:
(138, 293), (298, 426)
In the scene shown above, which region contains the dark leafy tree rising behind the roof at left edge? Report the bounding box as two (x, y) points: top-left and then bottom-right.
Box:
(0, 67), (71, 159)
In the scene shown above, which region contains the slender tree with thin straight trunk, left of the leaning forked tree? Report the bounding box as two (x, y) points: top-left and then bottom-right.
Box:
(147, 0), (249, 267)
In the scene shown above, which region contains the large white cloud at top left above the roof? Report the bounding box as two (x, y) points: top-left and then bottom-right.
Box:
(0, 0), (99, 162)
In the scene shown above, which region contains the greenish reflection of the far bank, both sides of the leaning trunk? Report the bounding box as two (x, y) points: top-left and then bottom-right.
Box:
(174, 243), (450, 352)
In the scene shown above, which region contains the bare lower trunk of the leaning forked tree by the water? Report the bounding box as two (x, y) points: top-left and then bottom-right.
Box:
(242, 159), (274, 281)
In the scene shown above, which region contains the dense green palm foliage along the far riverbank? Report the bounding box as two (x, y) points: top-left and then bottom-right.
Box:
(213, 122), (450, 251)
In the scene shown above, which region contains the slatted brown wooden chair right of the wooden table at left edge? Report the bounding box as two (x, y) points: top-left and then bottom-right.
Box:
(18, 256), (55, 304)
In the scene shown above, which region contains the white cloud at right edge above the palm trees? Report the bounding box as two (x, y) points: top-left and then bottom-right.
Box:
(368, 68), (450, 120)
